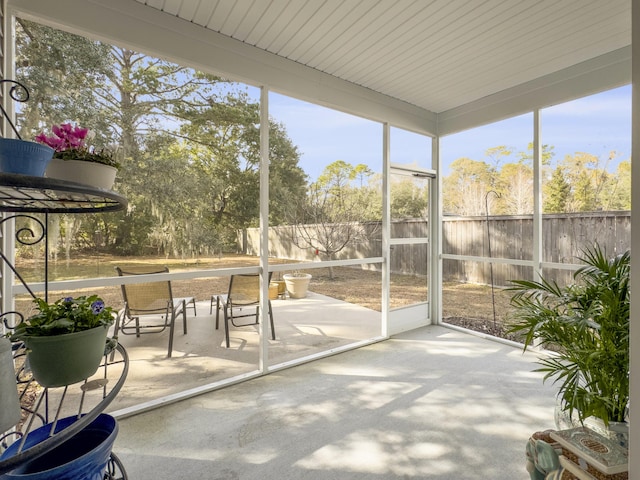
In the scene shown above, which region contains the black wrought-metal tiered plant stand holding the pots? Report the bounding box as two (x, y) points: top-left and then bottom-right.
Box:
(0, 173), (129, 480)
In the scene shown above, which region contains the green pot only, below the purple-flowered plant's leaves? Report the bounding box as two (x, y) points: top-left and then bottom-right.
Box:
(24, 326), (108, 387)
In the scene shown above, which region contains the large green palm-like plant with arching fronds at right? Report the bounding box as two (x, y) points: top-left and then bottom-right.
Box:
(509, 245), (630, 425)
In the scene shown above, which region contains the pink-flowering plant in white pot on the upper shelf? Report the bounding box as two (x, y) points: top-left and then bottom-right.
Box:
(35, 123), (120, 190)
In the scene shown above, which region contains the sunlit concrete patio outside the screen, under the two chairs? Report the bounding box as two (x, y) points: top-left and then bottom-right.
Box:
(108, 292), (381, 412)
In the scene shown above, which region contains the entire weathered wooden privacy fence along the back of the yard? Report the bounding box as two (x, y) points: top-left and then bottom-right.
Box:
(240, 211), (631, 286)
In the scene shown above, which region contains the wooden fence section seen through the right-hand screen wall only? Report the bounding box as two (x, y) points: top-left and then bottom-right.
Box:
(442, 211), (631, 286)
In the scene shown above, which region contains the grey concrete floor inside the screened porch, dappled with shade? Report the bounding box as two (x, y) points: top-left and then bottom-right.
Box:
(114, 326), (555, 480)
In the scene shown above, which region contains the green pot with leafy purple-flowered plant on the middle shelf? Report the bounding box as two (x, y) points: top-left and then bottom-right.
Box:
(9, 295), (114, 387)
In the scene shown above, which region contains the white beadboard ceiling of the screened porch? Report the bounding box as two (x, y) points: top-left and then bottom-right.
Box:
(134, 0), (631, 113)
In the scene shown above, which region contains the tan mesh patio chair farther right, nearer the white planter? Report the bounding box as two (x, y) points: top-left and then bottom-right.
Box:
(209, 272), (276, 348)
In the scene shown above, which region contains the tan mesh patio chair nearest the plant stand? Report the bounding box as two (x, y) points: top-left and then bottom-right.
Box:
(114, 265), (196, 357)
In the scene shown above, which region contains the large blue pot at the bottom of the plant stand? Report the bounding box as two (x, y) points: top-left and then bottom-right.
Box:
(0, 413), (118, 480)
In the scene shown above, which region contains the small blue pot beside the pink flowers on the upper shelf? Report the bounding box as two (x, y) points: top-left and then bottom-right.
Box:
(0, 138), (53, 177)
